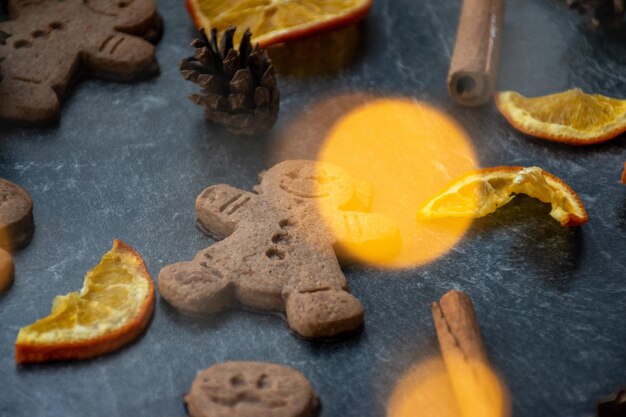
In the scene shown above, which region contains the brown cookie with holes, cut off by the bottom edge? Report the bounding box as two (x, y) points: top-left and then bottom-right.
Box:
(185, 362), (320, 417)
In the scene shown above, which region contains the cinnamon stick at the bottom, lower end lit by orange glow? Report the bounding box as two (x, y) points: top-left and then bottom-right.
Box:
(432, 290), (510, 417)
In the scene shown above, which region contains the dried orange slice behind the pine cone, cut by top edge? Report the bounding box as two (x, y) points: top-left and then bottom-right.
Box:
(185, 0), (372, 47)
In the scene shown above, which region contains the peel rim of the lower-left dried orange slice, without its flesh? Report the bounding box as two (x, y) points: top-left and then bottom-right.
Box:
(15, 240), (155, 364)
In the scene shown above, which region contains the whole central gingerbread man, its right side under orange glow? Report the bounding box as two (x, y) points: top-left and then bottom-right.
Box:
(159, 160), (400, 338)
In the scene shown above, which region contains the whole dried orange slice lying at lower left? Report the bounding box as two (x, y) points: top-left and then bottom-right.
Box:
(15, 240), (154, 363)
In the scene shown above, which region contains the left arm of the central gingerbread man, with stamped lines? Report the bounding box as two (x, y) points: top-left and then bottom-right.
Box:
(196, 184), (258, 239)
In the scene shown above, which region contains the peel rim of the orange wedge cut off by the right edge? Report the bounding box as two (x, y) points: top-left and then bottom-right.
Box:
(494, 88), (626, 146)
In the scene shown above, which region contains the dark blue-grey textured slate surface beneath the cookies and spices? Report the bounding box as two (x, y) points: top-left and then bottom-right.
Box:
(0, 0), (626, 417)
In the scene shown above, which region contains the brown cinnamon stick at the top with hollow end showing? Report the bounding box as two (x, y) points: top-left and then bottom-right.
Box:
(448, 0), (504, 106)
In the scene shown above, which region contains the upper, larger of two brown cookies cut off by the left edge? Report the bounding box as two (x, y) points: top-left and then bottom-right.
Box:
(0, 178), (34, 251)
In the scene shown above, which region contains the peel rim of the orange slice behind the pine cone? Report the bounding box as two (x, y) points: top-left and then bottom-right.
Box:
(185, 0), (372, 48)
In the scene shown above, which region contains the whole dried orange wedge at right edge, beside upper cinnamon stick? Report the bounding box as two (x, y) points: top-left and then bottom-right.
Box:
(495, 88), (626, 145)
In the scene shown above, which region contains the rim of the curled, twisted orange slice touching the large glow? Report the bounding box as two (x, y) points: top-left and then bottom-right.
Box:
(417, 166), (589, 226)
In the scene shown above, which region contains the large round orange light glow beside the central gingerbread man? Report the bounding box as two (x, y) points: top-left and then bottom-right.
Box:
(318, 98), (477, 268)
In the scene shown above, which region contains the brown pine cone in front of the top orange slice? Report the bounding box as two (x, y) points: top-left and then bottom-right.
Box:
(180, 26), (280, 135)
